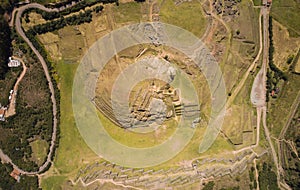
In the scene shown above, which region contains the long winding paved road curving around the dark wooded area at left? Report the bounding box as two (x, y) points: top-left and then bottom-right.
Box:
(0, 3), (58, 175)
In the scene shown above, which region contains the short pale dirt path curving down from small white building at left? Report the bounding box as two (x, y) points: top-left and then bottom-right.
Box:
(5, 56), (27, 117)
